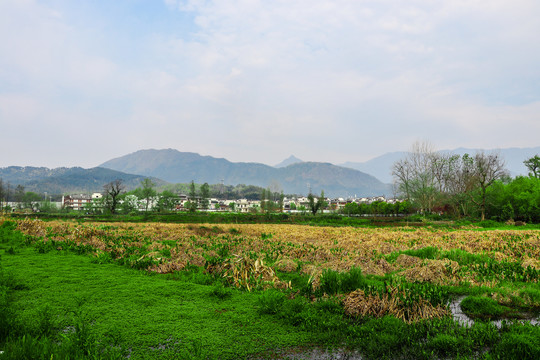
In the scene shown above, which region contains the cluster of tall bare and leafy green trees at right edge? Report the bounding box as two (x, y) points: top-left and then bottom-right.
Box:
(392, 142), (540, 222)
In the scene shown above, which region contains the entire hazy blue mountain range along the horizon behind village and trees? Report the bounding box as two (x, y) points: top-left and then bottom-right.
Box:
(0, 147), (540, 197)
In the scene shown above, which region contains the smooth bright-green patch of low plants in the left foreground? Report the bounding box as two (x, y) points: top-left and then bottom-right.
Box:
(0, 233), (313, 359)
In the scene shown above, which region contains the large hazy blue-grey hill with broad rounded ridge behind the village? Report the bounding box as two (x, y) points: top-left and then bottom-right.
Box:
(100, 149), (391, 197)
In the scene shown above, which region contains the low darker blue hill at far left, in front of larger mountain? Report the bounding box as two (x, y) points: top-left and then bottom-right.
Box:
(0, 166), (166, 194)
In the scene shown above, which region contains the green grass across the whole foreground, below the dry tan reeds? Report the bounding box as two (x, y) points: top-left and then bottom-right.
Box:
(0, 221), (540, 359)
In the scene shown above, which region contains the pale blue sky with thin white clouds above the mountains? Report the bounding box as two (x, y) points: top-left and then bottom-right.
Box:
(0, 0), (540, 168)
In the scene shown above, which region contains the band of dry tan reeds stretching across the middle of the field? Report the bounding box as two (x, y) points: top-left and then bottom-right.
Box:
(18, 220), (540, 286)
